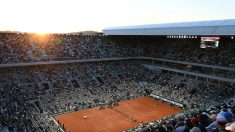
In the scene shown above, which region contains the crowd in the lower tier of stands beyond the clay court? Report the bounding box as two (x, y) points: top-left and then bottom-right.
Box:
(0, 61), (234, 131)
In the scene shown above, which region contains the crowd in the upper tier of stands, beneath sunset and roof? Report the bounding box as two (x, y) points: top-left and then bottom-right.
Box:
(0, 33), (235, 68)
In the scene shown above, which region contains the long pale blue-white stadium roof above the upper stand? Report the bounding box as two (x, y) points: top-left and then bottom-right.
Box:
(103, 19), (235, 36)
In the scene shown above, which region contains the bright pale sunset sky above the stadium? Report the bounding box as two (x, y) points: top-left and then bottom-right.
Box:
(0, 0), (235, 33)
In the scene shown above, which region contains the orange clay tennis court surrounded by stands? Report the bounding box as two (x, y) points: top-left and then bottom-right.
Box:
(54, 97), (182, 132)
